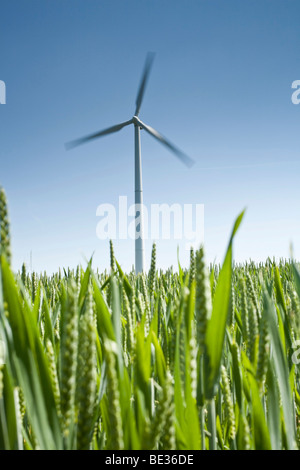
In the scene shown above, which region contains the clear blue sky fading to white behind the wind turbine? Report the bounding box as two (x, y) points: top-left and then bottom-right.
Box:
(0, 0), (300, 271)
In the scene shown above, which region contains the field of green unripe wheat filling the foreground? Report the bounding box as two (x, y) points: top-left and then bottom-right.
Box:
(0, 190), (300, 450)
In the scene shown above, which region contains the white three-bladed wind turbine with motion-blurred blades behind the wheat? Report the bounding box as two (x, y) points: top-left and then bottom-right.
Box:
(66, 52), (194, 273)
